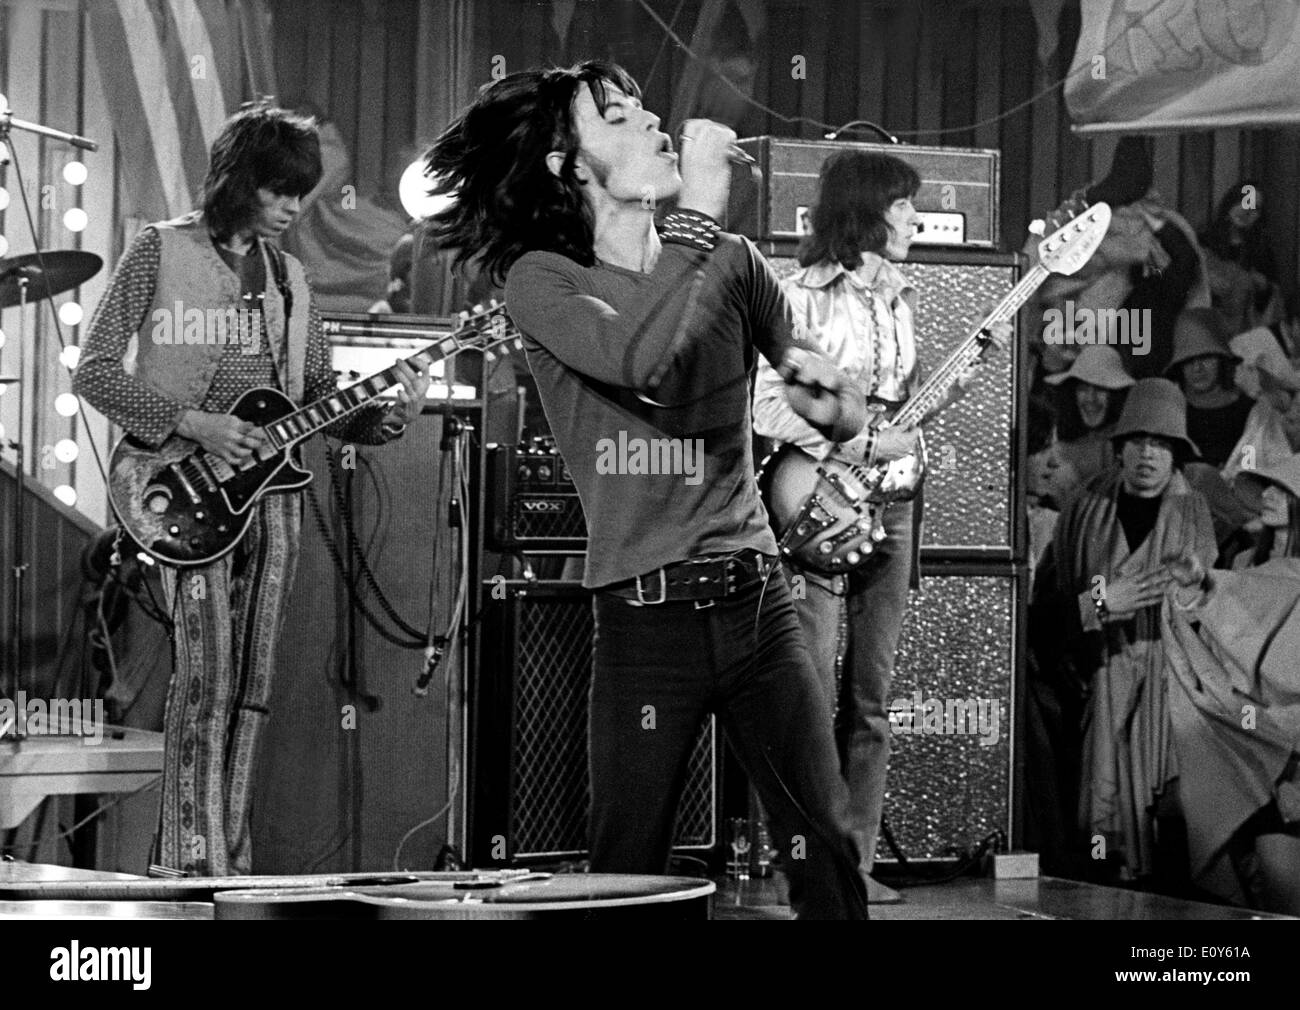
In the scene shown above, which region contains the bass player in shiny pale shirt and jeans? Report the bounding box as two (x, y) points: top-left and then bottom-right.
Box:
(754, 151), (1010, 902)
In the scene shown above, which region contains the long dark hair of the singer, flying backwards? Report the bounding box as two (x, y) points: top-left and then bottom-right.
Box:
(424, 60), (641, 283)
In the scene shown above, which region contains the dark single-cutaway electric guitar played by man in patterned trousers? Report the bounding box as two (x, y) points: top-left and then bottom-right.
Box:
(108, 302), (519, 568)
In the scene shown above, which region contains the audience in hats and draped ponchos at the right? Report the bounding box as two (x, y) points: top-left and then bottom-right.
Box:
(1024, 138), (1300, 913)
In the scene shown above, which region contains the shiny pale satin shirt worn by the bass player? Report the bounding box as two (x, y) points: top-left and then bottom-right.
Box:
(754, 252), (918, 460)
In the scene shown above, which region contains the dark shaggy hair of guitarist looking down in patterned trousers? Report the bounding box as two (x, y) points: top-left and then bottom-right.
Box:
(203, 101), (324, 242)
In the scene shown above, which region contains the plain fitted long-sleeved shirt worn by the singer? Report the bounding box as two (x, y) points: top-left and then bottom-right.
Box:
(506, 234), (852, 588)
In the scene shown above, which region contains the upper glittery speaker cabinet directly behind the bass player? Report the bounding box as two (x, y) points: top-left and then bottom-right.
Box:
(759, 243), (1023, 562)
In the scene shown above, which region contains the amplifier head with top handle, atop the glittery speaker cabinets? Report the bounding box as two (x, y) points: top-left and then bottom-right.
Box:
(725, 136), (1000, 248)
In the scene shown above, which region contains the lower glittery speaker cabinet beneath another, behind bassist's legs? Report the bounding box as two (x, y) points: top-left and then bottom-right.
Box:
(876, 563), (1023, 862)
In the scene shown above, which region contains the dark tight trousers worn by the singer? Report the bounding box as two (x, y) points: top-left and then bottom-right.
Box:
(589, 572), (867, 919)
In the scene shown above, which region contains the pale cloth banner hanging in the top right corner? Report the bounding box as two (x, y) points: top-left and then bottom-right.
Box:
(1065, 0), (1300, 133)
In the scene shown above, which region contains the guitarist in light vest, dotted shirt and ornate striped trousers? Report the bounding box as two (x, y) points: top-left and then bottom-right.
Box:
(73, 104), (429, 876)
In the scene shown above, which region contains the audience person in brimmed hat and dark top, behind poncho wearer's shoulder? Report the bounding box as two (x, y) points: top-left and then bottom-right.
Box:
(1165, 308), (1255, 469)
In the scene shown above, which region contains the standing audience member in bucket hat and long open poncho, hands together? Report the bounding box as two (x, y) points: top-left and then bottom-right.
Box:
(1036, 378), (1217, 883)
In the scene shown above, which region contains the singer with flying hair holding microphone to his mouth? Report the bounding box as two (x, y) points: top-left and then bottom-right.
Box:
(426, 61), (867, 919)
